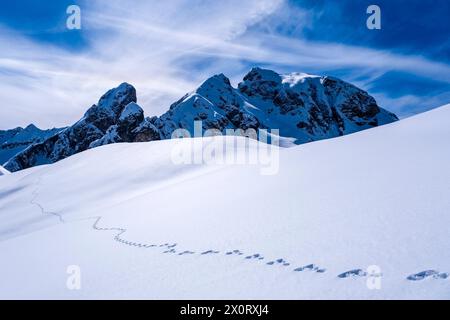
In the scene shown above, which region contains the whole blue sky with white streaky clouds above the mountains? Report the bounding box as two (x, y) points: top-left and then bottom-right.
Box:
(0, 0), (450, 128)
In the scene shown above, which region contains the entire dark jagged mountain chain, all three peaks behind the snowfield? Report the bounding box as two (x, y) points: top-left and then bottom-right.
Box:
(5, 68), (398, 171)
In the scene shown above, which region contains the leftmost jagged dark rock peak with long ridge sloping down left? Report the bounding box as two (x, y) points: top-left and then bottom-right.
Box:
(5, 83), (148, 171)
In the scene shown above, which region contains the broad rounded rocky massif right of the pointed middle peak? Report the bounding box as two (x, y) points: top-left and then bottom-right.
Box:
(238, 68), (398, 144)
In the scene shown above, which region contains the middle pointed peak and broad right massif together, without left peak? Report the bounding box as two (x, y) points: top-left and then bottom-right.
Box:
(154, 68), (398, 144)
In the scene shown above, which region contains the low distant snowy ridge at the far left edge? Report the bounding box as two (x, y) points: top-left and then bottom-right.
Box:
(0, 124), (63, 164)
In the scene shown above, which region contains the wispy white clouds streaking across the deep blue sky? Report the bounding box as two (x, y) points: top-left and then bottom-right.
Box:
(0, 0), (450, 128)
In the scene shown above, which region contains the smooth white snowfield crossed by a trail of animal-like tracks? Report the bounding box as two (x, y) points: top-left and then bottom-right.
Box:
(0, 105), (450, 299)
